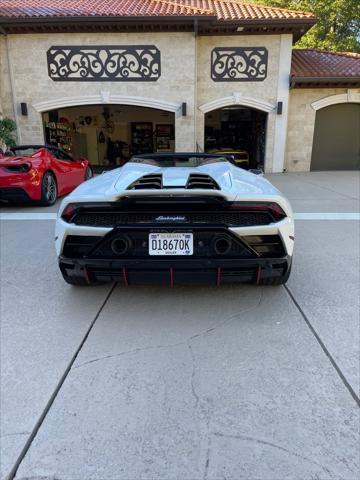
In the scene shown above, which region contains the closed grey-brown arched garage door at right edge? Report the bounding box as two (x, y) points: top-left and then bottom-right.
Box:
(311, 103), (360, 170)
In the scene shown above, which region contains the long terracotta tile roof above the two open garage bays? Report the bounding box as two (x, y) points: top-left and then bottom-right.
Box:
(0, 0), (315, 20)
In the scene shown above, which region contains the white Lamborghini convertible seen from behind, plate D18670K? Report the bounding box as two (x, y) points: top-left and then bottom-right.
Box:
(55, 153), (294, 286)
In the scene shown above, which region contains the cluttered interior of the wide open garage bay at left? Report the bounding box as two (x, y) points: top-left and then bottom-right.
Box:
(43, 105), (175, 170)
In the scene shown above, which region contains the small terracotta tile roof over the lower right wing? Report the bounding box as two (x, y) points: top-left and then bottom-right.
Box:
(291, 49), (360, 78)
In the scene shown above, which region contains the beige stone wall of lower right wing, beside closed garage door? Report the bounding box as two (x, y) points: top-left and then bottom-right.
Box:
(285, 88), (360, 172)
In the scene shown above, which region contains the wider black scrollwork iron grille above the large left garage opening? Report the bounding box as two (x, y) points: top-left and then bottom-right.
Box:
(47, 45), (161, 82)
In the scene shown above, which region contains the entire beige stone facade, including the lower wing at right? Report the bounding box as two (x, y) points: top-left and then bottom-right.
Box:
(0, 32), (358, 172)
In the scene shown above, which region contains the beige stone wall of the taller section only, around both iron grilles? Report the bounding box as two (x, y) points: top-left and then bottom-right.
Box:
(1, 33), (291, 170)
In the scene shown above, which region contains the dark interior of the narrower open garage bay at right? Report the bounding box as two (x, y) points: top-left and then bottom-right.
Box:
(205, 106), (267, 169)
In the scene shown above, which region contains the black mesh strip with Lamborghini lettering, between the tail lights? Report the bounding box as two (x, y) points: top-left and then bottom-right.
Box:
(72, 211), (273, 228)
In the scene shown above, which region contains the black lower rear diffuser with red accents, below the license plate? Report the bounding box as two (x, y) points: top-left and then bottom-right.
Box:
(59, 255), (291, 287)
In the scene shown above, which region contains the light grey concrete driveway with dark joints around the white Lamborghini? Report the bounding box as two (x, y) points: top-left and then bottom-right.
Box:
(0, 172), (360, 480)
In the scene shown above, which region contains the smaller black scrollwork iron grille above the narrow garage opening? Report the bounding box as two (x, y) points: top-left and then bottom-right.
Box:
(211, 47), (268, 82)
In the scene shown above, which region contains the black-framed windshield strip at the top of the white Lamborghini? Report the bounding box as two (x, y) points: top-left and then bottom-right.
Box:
(130, 155), (230, 168)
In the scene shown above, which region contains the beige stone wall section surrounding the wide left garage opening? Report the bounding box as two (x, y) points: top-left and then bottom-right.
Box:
(4, 33), (195, 151)
